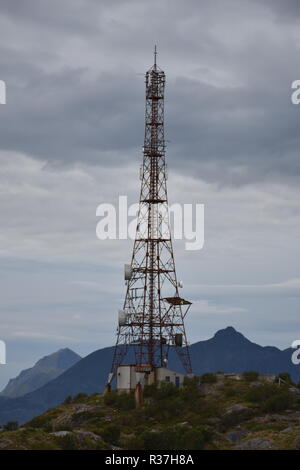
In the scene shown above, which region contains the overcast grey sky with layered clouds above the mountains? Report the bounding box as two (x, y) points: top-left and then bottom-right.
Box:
(0, 0), (300, 387)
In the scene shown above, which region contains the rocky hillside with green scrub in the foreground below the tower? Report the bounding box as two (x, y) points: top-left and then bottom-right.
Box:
(0, 373), (300, 450)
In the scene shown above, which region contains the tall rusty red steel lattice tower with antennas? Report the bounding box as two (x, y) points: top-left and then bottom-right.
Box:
(111, 47), (192, 377)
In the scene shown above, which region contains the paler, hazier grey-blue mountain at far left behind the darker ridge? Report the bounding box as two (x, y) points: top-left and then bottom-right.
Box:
(0, 348), (81, 398)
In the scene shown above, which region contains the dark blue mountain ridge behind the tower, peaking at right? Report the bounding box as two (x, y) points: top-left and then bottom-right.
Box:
(0, 327), (300, 424)
